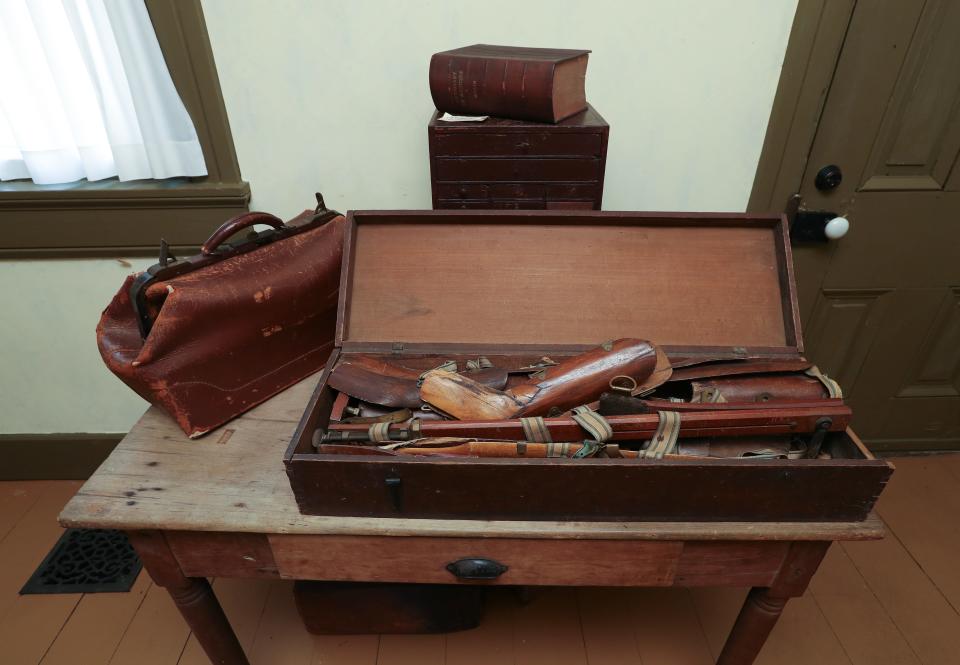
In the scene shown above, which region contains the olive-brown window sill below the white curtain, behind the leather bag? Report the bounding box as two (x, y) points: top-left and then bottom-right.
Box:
(0, 178), (250, 259)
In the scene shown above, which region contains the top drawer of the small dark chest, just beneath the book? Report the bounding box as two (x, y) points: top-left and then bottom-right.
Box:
(435, 132), (603, 157)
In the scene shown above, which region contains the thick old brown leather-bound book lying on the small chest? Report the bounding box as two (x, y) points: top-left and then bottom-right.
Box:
(430, 44), (590, 122)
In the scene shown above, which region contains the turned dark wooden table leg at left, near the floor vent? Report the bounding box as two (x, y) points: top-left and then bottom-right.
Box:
(127, 531), (249, 665)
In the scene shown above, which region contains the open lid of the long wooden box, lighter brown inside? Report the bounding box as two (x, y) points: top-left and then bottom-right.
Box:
(336, 210), (803, 359)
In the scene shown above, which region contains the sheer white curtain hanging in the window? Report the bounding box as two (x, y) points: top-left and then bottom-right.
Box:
(0, 0), (207, 184)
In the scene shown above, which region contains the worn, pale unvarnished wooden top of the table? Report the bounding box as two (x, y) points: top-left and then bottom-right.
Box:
(60, 374), (883, 540)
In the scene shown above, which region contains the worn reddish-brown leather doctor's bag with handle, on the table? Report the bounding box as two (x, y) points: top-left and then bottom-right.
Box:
(97, 196), (344, 438)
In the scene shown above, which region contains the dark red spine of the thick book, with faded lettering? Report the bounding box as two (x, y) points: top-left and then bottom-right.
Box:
(430, 54), (556, 122)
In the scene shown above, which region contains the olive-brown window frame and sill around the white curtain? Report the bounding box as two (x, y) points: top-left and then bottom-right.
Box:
(0, 0), (250, 259)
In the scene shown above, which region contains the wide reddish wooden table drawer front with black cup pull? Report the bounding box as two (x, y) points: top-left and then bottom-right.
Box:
(269, 534), (683, 586)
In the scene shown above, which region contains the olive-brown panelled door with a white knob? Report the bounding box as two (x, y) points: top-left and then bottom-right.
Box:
(794, 0), (960, 450)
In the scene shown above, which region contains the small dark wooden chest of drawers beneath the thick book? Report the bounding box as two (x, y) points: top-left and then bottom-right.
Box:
(427, 106), (610, 210)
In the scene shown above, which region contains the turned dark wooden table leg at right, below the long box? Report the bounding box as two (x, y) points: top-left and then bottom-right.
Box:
(717, 542), (830, 665)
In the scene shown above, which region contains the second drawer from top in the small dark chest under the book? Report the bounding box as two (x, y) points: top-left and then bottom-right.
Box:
(433, 157), (601, 182)
